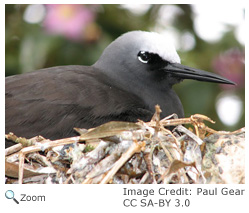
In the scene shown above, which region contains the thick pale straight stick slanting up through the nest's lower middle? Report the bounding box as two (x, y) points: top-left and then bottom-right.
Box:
(100, 142), (146, 184)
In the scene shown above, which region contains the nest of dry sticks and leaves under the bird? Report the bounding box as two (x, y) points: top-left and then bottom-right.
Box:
(5, 106), (245, 184)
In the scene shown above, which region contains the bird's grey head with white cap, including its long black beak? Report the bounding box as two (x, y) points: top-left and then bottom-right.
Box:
(93, 31), (234, 87)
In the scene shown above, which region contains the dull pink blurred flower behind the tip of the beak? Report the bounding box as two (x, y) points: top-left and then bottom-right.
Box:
(213, 49), (245, 89)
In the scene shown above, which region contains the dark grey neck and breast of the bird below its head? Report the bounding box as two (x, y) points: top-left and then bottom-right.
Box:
(92, 64), (184, 117)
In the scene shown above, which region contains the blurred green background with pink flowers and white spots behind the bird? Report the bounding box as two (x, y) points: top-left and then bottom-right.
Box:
(5, 4), (245, 130)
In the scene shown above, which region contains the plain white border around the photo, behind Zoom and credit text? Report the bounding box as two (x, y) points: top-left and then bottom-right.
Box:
(0, 0), (249, 213)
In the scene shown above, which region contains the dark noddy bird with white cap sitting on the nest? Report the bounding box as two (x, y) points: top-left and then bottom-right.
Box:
(5, 31), (234, 147)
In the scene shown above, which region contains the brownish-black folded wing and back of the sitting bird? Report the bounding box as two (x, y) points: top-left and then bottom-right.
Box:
(5, 66), (152, 139)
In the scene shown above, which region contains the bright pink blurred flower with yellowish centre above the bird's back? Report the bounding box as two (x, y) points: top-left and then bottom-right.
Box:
(43, 4), (95, 40)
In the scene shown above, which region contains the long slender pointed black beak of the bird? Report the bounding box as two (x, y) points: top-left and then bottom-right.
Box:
(164, 63), (236, 85)
